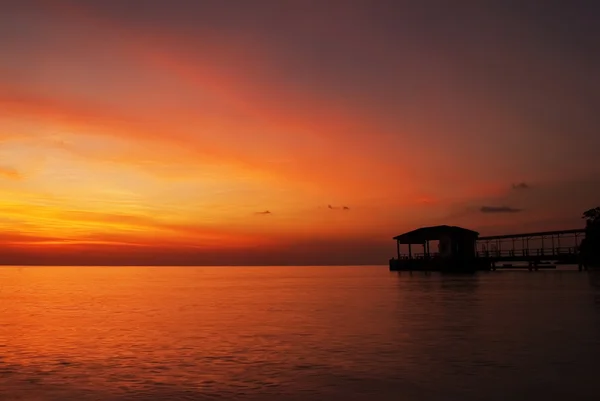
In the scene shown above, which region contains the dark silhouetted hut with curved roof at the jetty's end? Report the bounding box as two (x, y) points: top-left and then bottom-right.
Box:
(390, 225), (479, 270)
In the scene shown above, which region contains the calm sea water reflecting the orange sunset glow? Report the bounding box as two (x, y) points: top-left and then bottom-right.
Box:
(0, 267), (600, 401)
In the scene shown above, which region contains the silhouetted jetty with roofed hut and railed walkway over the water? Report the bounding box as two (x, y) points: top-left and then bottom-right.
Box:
(389, 225), (585, 272)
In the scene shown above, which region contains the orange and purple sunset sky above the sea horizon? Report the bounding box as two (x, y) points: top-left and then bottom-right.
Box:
(0, 0), (600, 265)
